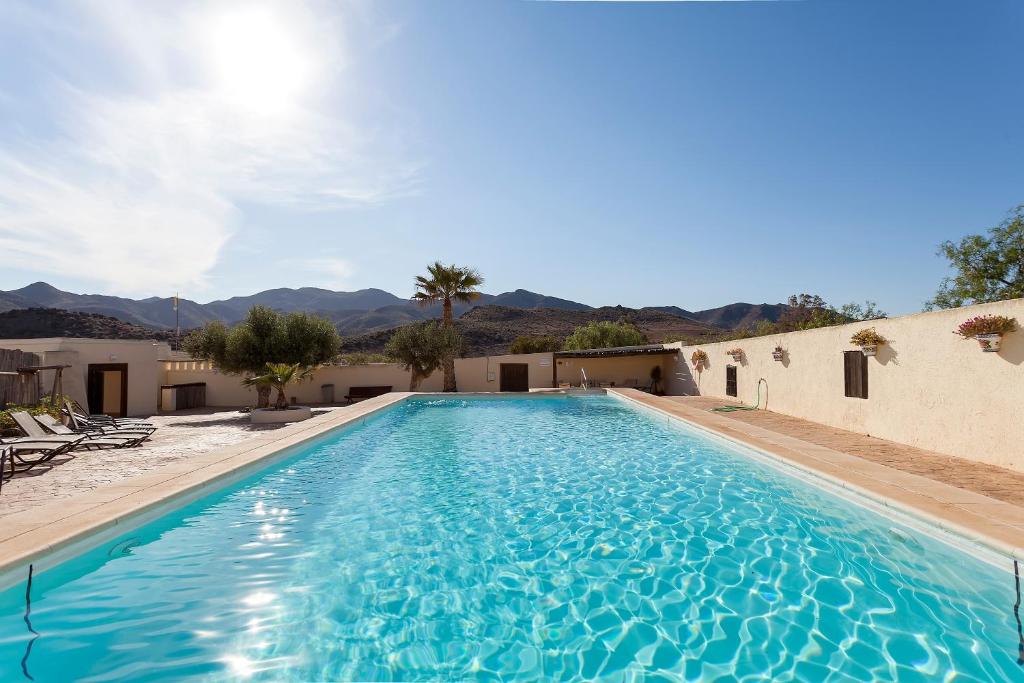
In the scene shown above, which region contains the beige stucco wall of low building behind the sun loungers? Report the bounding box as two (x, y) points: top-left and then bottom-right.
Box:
(0, 338), (168, 415)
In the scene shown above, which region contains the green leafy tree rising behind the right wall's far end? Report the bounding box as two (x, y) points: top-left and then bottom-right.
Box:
(925, 204), (1024, 310)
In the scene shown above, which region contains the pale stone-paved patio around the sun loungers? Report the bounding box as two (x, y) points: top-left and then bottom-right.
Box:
(0, 408), (341, 517)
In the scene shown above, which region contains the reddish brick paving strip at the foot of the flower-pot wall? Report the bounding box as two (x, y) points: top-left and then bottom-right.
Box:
(666, 396), (1024, 507)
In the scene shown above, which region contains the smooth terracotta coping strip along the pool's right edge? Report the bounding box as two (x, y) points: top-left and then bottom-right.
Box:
(607, 388), (1024, 561)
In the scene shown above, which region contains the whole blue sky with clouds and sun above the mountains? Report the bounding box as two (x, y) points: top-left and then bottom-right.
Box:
(0, 0), (1024, 313)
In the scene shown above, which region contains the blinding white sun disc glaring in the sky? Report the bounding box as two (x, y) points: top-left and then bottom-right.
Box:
(199, 7), (312, 115)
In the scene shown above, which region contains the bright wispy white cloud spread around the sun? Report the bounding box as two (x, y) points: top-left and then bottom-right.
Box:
(0, 2), (420, 294)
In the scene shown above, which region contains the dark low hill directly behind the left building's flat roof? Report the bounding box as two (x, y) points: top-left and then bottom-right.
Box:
(0, 308), (180, 343)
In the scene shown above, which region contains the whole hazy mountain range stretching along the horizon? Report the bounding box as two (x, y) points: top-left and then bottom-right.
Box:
(0, 283), (786, 353)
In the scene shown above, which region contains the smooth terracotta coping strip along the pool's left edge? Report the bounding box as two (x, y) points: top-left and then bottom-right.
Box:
(0, 392), (418, 590)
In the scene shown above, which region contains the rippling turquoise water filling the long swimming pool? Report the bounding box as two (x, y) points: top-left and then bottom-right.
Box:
(0, 396), (1024, 681)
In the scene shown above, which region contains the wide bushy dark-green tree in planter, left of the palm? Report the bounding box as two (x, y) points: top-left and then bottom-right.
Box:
(182, 305), (341, 408)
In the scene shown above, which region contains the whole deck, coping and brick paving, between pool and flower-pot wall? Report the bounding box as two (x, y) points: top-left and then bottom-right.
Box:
(608, 389), (1024, 560)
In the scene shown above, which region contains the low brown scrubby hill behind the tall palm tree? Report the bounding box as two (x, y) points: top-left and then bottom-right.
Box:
(344, 305), (722, 355)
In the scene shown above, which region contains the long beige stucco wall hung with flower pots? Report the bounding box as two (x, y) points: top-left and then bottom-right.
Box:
(669, 299), (1024, 471)
